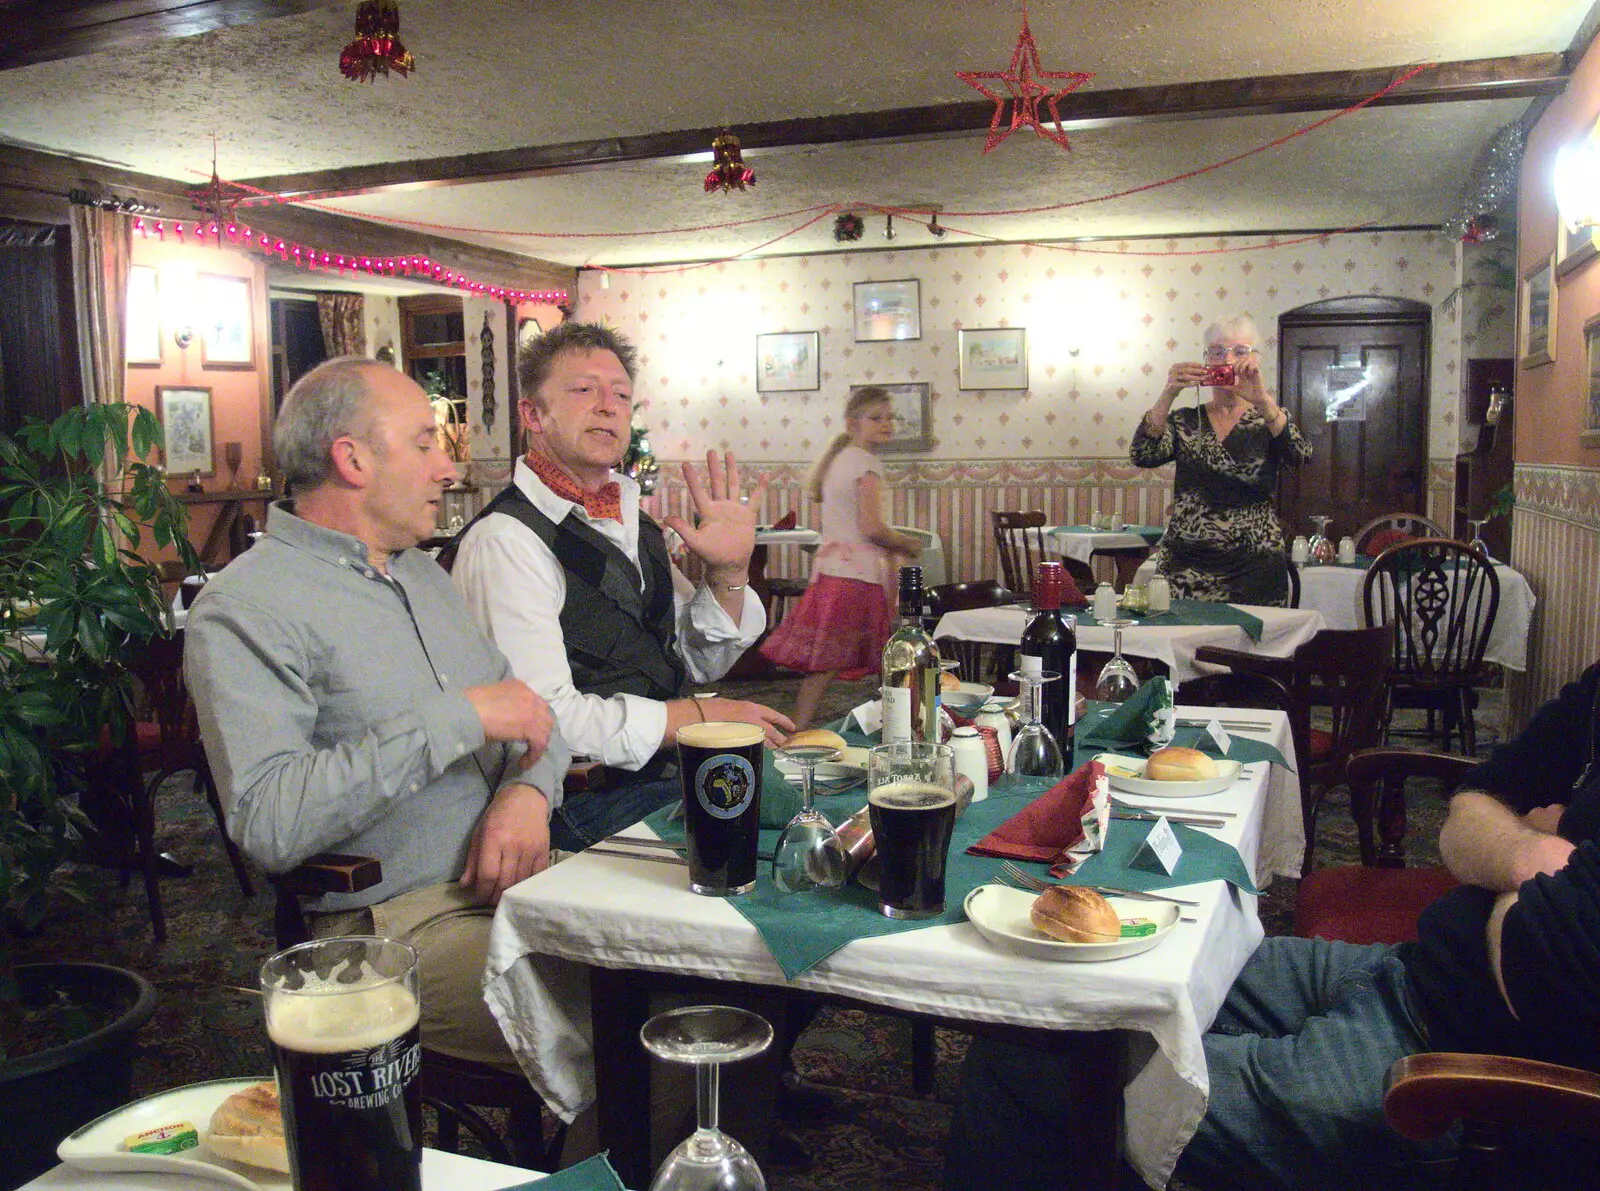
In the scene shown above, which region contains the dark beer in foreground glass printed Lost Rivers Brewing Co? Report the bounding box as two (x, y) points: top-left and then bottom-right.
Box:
(261, 936), (422, 1191)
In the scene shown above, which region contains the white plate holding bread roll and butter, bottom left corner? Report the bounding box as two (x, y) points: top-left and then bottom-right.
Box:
(56, 1076), (291, 1191)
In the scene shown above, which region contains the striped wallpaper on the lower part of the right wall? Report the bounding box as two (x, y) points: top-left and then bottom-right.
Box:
(1506, 463), (1600, 730)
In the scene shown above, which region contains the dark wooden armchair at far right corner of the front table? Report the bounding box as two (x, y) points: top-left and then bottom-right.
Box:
(1195, 624), (1392, 868)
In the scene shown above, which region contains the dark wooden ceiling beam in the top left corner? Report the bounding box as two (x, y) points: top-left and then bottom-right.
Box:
(0, 0), (338, 70)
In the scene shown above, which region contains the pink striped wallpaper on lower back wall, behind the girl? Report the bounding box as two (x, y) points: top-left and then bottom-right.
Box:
(645, 456), (1173, 583)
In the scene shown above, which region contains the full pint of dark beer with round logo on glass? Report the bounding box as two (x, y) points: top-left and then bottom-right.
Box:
(678, 722), (766, 896)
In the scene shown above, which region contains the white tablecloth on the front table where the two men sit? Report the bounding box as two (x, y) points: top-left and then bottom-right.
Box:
(485, 709), (1302, 1186)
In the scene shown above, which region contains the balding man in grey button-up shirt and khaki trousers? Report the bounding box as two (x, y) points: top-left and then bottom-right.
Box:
(184, 359), (570, 1069)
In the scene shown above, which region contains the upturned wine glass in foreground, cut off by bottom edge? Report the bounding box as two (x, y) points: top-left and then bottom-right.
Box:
(638, 1005), (773, 1191)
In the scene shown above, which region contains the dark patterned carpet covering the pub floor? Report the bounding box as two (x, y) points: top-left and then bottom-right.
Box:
(22, 680), (1499, 1191)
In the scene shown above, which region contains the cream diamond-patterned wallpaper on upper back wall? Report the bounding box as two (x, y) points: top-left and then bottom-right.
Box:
(578, 231), (1461, 464)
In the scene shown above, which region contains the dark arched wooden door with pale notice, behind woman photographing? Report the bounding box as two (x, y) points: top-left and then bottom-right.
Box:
(1278, 307), (1429, 536)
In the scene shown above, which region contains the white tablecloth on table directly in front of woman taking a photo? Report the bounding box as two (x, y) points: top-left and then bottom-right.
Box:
(933, 604), (1326, 684)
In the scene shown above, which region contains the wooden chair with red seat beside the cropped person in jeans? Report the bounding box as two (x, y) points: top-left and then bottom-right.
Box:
(1294, 749), (1477, 943)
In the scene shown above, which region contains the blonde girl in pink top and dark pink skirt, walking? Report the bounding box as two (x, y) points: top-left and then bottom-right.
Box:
(762, 384), (922, 728)
